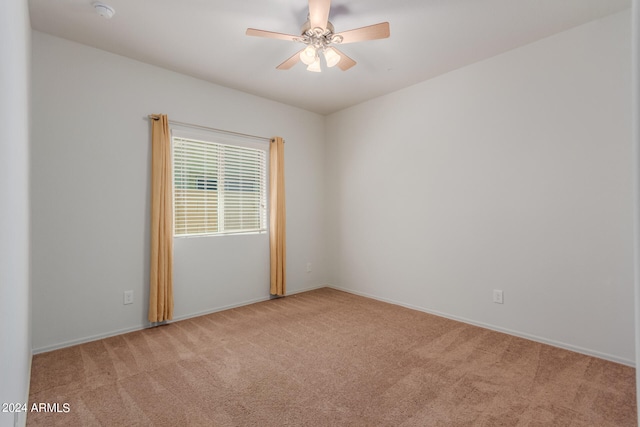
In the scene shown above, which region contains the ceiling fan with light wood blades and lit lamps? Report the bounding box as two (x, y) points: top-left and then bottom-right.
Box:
(246, 0), (390, 72)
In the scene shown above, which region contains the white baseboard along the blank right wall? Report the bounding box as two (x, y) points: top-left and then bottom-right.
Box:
(327, 285), (635, 368)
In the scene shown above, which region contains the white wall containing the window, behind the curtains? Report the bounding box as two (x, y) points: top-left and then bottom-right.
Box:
(31, 32), (327, 351)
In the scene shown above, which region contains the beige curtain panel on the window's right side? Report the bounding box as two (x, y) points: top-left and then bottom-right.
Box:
(269, 137), (287, 296)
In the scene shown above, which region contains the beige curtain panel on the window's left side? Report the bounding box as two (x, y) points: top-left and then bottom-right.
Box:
(149, 114), (173, 322)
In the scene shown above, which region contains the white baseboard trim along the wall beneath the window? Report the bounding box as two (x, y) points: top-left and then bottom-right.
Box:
(32, 285), (327, 355)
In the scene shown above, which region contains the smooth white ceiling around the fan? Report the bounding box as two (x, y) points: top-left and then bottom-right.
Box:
(29, 0), (631, 114)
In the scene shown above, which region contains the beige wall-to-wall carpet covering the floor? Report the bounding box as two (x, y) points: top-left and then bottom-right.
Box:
(27, 288), (636, 427)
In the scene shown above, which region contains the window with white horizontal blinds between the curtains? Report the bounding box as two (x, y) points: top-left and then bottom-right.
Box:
(172, 132), (269, 237)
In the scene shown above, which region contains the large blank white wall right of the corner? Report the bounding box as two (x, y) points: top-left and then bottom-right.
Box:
(325, 11), (635, 364)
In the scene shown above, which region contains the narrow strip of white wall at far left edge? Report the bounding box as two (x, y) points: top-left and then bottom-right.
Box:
(0, 1), (31, 426)
